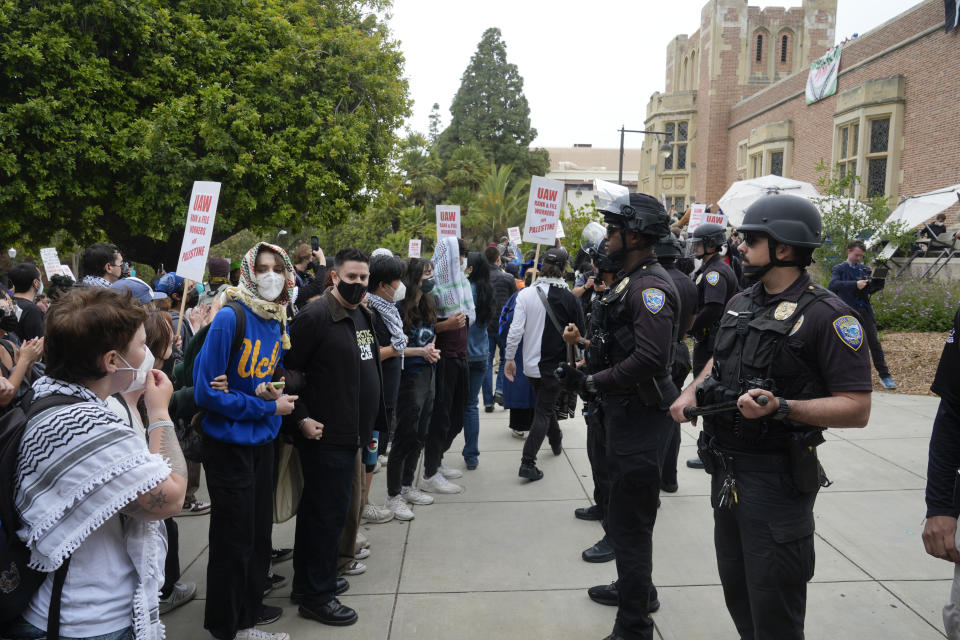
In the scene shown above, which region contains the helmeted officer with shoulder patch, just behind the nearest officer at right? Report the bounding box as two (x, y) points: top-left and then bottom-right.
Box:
(687, 222), (740, 469)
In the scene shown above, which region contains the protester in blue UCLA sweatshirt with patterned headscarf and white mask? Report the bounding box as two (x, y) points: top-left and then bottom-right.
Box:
(193, 242), (297, 640)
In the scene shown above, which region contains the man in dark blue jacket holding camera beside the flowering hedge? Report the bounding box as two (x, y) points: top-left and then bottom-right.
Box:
(828, 240), (897, 390)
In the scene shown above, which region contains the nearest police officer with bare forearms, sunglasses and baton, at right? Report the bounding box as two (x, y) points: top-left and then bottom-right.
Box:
(671, 195), (871, 640)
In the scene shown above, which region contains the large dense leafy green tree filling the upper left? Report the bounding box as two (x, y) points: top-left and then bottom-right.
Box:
(0, 0), (408, 264)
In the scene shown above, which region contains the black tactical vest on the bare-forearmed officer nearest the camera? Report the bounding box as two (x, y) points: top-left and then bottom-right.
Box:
(697, 283), (835, 451)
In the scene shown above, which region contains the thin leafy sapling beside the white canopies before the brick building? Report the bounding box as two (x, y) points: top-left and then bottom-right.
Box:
(814, 160), (911, 273)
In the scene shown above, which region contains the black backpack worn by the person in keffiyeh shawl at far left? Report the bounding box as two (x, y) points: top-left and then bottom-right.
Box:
(0, 391), (83, 638)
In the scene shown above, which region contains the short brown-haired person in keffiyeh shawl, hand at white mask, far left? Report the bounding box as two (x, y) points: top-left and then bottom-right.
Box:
(3, 288), (186, 640)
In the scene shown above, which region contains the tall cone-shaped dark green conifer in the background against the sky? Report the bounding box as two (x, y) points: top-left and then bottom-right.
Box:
(437, 28), (550, 178)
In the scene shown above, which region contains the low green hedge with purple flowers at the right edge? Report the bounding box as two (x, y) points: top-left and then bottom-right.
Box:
(871, 278), (960, 331)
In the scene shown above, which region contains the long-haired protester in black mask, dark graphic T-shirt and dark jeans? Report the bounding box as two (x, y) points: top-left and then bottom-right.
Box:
(384, 258), (440, 520)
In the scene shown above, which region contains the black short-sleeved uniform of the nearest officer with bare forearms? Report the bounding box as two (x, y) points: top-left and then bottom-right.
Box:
(697, 272), (871, 640)
